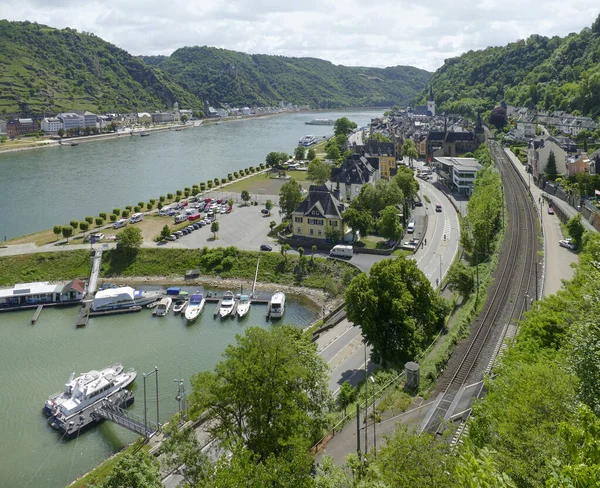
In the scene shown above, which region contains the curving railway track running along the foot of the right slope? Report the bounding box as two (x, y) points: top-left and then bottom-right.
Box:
(422, 141), (538, 434)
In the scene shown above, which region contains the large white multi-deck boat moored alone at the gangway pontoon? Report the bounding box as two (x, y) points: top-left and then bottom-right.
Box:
(43, 364), (137, 419)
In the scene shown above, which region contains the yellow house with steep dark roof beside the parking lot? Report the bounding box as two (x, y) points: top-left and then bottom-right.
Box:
(292, 185), (346, 240)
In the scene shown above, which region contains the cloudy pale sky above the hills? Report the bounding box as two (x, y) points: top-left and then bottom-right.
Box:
(0, 0), (600, 71)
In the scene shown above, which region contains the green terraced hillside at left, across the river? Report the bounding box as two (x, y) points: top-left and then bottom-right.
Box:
(0, 20), (202, 115)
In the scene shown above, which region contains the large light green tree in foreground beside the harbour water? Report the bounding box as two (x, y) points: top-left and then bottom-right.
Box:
(190, 326), (331, 461)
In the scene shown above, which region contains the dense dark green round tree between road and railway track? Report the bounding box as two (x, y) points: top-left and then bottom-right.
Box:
(346, 256), (447, 365)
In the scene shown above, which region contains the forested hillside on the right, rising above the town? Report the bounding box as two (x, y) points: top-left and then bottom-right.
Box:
(421, 17), (600, 115)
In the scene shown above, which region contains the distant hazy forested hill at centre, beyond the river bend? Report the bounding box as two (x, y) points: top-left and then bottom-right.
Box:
(142, 46), (431, 107)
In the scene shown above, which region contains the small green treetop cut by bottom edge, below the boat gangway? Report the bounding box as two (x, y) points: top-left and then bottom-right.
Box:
(100, 449), (163, 488)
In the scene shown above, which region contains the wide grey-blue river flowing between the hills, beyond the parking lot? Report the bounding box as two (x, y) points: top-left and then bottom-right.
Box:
(0, 110), (382, 240)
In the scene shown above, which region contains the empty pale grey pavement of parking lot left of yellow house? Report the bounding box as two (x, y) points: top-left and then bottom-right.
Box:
(158, 204), (281, 251)
